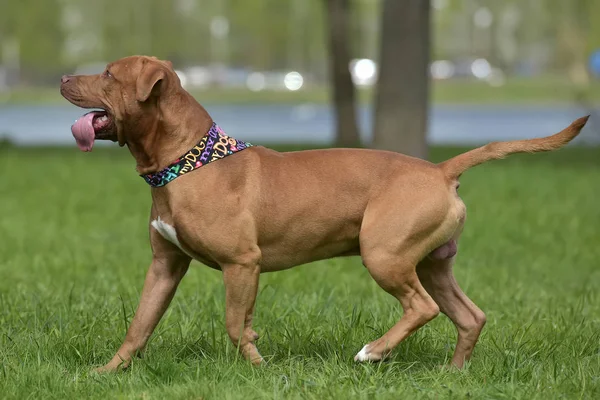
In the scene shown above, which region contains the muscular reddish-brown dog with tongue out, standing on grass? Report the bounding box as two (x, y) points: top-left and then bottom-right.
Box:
(61, 56), (587, 371)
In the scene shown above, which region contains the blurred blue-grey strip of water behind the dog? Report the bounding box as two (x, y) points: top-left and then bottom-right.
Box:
(0, 104), (600, 146)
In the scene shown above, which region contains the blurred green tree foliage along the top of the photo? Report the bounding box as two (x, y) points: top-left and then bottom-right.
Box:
(0, 0), (600, 84)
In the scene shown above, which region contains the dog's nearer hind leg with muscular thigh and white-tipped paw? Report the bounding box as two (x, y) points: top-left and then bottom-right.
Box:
(354, 174), (462, 361)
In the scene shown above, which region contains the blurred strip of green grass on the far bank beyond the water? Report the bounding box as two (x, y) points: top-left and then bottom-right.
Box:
(0, 76), (600, 105)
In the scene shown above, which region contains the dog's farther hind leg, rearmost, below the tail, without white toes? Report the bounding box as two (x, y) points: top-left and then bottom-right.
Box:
(417, 257), (486, 368)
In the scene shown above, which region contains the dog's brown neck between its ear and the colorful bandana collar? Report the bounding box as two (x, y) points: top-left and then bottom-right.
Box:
(127, 92), (213, 174)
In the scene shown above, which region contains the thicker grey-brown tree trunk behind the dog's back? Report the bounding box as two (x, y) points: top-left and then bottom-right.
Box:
(373, 0), (430, 158)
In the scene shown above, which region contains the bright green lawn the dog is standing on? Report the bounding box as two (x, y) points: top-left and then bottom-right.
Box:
(0, 147), (600, 399)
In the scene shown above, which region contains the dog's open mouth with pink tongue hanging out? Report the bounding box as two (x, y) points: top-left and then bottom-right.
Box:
(71, 110), (117, 151)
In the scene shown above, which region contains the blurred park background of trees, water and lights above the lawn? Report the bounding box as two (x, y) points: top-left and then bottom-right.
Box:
(0, 0), (600, 153)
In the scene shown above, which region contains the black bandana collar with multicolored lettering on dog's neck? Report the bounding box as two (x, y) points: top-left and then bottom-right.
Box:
(140, 122), (252, 187)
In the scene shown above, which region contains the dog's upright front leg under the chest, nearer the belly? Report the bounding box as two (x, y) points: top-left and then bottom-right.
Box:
(221, 263), (263, 364)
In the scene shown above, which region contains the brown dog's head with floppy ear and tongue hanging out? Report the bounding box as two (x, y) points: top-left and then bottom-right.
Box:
(60, 56), (183, 151)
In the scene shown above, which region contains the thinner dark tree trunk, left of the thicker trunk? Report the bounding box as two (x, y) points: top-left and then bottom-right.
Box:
(325, 0), (360, 147)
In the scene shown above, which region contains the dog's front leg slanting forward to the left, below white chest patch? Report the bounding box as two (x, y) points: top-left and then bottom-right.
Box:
(96, 249), (190, 372)
